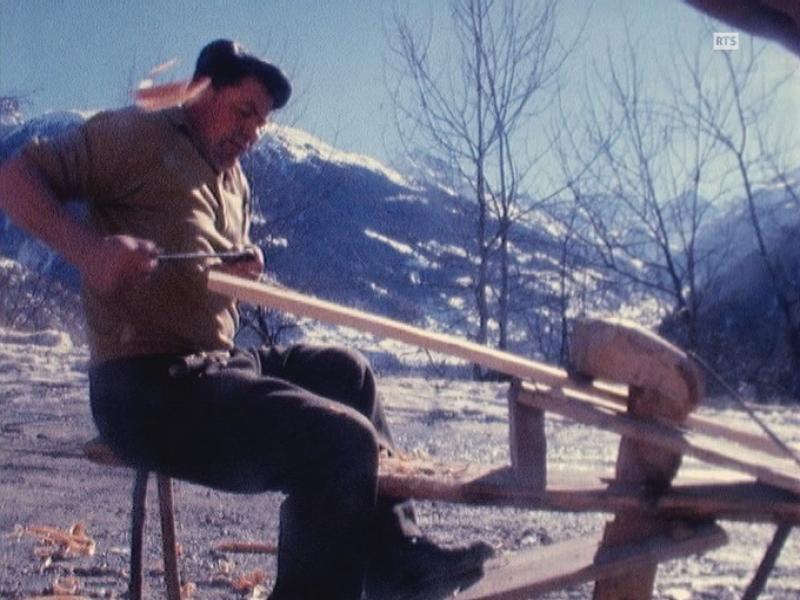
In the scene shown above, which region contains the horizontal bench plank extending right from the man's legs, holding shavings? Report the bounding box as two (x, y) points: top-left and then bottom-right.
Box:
(379, 457), (800, 524)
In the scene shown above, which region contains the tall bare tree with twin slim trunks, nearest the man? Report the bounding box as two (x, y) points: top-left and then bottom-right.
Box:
(390, 0), (570, 360)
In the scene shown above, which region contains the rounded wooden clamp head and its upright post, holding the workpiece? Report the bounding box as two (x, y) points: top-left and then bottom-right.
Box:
(570, 320), (702, 600)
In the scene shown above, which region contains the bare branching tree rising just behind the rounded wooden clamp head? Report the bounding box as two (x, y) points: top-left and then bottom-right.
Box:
(562, 32), (722, 346)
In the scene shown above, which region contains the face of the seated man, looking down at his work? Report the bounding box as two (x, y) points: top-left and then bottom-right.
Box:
(197, 77), (272, 169)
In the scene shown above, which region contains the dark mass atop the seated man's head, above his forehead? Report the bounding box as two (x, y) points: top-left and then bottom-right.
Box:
(194, 40), (292, 109)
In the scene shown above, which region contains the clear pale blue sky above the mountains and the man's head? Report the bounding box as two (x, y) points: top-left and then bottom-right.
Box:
(0, 0), (797, 166)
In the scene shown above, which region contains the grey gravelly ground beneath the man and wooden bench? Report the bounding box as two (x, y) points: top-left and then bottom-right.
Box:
(0, 330), (800, 600)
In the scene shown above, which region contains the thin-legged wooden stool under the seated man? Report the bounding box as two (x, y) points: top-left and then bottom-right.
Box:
(83, 437), (181, 600)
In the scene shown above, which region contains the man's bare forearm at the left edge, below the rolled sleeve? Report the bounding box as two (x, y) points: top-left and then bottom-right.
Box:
(0, 156), (101, 269)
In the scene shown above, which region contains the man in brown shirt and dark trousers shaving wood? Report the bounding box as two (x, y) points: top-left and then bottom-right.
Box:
(0, 40), (491, 600)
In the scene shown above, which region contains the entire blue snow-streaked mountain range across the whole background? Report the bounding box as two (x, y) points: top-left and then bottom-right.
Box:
(0, 112), (800, 396)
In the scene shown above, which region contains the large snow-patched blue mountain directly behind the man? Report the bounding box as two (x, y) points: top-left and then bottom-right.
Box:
(0, 112), (580, 358)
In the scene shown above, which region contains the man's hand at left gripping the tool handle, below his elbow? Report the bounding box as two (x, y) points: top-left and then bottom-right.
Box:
(78, 235), (160, 295)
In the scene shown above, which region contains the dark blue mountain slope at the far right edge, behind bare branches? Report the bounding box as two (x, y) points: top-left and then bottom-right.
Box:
(684, 178), (800, 396)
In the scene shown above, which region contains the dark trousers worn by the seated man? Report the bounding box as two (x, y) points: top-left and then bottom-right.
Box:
(90, 345), (418, 600)
